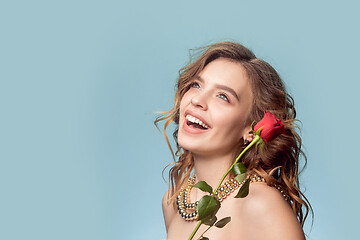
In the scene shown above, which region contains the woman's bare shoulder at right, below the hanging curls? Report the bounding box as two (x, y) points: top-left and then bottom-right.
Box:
(234, 183), (305, 240)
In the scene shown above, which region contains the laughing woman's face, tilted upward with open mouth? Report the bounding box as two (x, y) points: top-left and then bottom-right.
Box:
(178, 58), (253, 156)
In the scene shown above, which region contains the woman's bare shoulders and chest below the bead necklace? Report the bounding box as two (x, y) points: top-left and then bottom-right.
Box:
(163, 182), (305, 240)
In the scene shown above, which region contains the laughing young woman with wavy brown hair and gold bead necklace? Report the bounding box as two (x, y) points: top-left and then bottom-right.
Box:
(156, 42), (311, 240)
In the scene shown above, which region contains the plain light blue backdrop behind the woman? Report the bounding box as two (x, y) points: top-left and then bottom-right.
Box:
(0, 0), (360, 240)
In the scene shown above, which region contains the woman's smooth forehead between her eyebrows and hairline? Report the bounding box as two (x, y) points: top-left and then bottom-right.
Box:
(199, 58), (251, 95)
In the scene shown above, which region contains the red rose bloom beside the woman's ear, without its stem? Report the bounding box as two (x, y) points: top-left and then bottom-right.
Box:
(254, 112), (286, 142)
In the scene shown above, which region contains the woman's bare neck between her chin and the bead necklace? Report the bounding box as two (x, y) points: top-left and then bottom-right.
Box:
(193, 153), (234, 190)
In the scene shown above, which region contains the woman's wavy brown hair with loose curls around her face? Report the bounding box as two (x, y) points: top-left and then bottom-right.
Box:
(155, 42), (313, 226)
